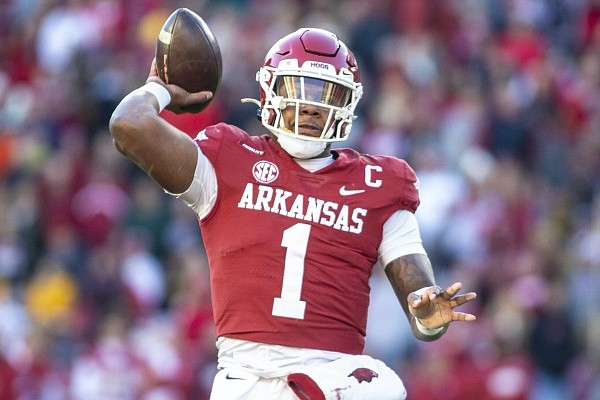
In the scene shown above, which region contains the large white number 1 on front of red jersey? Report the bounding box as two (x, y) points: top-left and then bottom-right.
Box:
(272, 223), (310, 319)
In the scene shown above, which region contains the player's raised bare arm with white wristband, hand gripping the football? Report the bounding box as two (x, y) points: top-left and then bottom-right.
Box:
(109, 60), (212, 193)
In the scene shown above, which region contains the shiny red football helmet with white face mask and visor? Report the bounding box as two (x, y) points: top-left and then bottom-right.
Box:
(243, 28), (362, 142)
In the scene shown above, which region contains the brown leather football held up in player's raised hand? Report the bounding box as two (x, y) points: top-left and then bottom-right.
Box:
(156, 8), (223, 113)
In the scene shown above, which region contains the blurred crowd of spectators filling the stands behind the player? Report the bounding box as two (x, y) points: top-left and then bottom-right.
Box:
(0, 0), (600, 400)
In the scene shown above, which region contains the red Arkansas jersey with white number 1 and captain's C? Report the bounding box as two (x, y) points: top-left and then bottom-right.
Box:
(197, 124), (419, 354)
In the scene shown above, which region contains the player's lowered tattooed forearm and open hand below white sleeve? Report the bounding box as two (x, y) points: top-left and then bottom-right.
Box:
(385, 254), (477, 341)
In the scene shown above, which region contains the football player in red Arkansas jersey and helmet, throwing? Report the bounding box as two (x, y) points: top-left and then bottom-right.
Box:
(110, 28), (476, 400)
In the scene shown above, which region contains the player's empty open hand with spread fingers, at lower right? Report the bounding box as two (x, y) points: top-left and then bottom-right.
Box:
(407, 282), (477, 329)
